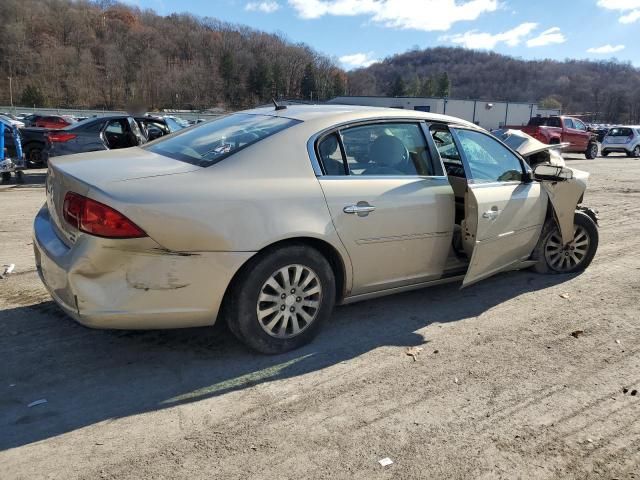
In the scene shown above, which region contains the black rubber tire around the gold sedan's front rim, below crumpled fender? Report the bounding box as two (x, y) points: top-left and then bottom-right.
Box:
(531, 212), (599, 274)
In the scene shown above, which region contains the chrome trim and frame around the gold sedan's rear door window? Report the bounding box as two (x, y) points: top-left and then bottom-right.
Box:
(307, 117), (464, 179)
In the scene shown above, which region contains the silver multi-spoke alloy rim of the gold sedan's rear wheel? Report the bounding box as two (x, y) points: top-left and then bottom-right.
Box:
(256, 264), (322, 339)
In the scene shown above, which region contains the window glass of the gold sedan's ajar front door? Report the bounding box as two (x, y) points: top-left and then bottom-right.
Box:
(456, 129), (522, 183)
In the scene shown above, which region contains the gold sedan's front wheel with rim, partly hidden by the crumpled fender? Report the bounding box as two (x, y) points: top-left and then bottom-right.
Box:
(533, 212), (598, 273)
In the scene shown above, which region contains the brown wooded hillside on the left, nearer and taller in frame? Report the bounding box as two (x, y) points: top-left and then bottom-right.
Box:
(0, 0), (346, 109)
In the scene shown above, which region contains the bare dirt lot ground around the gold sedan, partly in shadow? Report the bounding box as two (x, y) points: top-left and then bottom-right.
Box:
(0, 156), (640, 480)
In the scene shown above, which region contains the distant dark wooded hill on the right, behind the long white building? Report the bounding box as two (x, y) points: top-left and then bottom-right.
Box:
(349, 47), (640, 123)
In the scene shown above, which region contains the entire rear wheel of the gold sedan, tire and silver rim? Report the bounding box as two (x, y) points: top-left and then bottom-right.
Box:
(225, 245), (335, 354)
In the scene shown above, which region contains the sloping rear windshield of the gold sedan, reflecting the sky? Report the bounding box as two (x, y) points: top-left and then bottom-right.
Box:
(142, 113), (300, 167)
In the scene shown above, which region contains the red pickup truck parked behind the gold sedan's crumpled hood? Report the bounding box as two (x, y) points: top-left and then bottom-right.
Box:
(507, 116), (598, 159)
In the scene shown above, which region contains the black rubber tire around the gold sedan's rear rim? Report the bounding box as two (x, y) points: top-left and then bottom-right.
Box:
(224, 245), (336, 354)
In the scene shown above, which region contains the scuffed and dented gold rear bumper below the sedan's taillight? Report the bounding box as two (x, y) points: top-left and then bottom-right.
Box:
(33, 205), (253, 329)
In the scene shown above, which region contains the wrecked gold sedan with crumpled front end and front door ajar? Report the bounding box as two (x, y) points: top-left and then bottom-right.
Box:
(34, 106), (598, 353)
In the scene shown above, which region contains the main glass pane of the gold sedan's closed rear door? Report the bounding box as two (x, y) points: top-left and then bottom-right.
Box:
(340, 122), (434, 176)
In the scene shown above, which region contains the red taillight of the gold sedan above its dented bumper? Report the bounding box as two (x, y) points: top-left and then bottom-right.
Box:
(63, 192), (147, 238)
